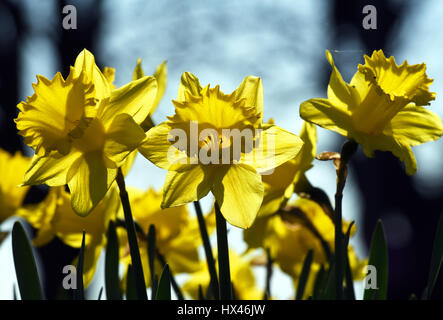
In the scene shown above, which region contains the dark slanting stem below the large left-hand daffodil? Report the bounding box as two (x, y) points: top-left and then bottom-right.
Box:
(116, 168), (148, 300)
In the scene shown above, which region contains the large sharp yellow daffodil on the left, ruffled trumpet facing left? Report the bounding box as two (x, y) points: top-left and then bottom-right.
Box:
(15, 50), (157, 216)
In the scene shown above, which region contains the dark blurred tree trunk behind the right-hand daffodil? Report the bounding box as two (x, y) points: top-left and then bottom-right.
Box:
(332, 0), (443, 299)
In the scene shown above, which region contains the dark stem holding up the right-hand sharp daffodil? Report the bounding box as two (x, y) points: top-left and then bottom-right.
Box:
(334, 140), (358, 300)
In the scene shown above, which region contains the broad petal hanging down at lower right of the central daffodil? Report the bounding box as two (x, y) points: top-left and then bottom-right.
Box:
(212, 164), (264, 229)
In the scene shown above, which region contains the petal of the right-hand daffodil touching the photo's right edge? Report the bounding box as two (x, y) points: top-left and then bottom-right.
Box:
(384, 104), (443, 146)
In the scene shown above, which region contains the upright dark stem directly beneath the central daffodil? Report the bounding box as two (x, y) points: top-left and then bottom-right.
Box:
(215, 202), (232, 300)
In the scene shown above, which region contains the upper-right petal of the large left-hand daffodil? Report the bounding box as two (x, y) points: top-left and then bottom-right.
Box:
(97, 77), (157, 129)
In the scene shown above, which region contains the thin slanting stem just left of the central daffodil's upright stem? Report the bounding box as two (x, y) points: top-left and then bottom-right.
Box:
(194, 201), (220, 300)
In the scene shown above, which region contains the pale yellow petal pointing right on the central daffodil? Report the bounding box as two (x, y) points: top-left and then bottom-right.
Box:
(250, 125), (303, 174)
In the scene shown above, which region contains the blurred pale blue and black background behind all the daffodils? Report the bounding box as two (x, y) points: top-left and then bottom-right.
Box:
(0, 0), (443, 299)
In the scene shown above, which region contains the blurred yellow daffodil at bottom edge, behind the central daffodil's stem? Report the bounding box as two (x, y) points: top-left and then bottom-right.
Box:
(183, 250), (264, 300)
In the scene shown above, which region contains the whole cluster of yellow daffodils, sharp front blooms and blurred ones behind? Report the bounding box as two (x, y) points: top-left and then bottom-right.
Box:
(0, 50), (443, 299)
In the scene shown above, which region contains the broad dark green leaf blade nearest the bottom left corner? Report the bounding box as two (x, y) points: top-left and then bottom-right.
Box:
(12, 221), (43, 300)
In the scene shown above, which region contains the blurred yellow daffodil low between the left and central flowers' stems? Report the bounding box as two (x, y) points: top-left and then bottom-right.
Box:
(119, 188), (208, 286)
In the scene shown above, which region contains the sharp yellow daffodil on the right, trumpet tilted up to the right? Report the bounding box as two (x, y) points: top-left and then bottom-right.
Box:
(300, 50), (443, 175)
